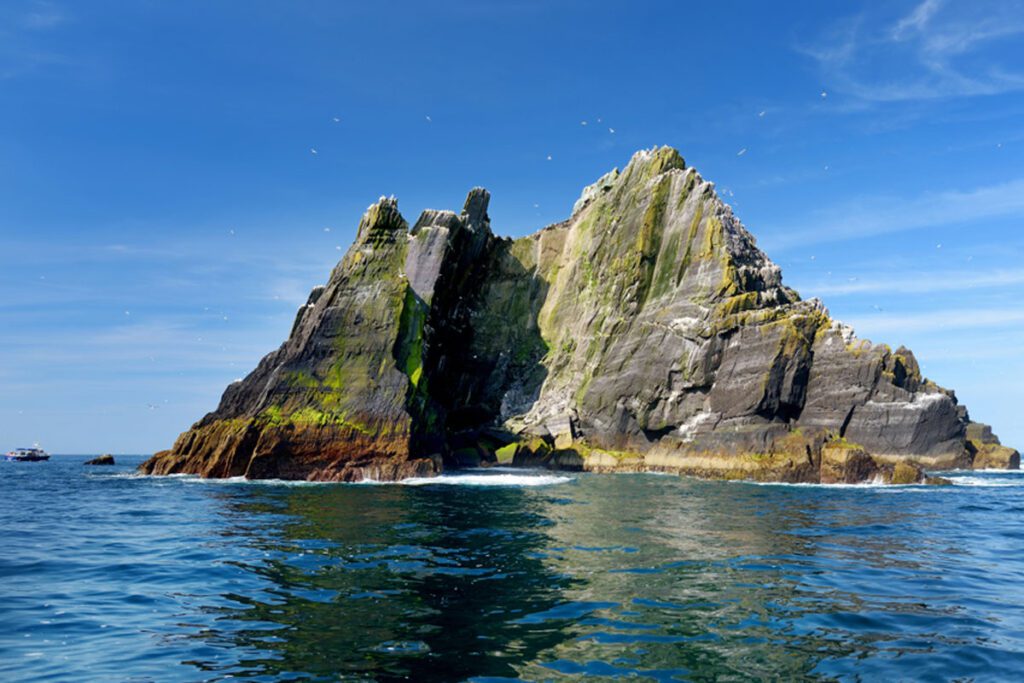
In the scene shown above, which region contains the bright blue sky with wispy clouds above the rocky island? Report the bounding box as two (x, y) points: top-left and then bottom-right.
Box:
(0, 0), (1024, 453)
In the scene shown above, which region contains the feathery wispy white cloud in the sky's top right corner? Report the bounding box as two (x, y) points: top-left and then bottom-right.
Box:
(799, 0), (1024, 102)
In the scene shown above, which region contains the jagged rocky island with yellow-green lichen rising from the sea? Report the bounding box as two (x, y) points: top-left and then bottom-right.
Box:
(142, 147), (1019, 481)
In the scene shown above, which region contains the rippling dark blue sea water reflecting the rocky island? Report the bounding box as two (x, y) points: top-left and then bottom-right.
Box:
(0, 456), (1024, 681)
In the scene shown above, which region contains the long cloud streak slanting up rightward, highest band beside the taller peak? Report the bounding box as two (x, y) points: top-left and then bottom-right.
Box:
(764, 178), (1024, 249)
